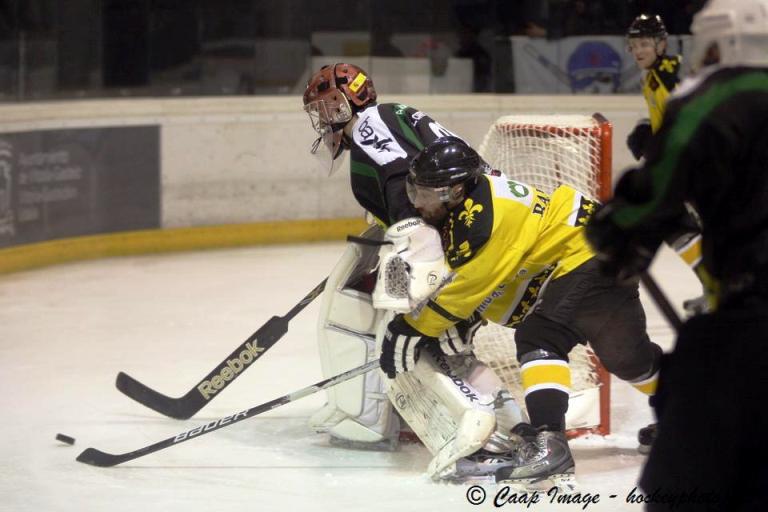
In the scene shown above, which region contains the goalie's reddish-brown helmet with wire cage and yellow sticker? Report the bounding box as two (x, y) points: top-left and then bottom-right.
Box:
(304, 63), (376, 172)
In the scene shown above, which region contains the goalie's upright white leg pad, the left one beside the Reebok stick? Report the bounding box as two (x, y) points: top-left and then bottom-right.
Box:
(310, 228), (399, 443)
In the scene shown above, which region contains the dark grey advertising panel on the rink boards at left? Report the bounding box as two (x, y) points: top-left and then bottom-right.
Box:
(0, 126), (160, 247)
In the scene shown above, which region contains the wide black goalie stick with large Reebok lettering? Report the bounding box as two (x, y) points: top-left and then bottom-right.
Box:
(115, 278), (328, 420)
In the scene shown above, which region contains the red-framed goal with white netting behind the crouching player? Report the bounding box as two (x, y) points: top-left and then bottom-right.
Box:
(475, 114), (611, 435)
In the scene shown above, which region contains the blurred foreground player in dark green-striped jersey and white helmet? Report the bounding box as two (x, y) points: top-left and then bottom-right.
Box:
(587, 0), (768, 510)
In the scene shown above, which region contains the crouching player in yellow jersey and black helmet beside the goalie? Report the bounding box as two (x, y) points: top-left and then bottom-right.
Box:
(380, 137), (661, 486)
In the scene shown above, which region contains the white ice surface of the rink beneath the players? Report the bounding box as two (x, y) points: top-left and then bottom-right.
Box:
(0, 243), (700, 512)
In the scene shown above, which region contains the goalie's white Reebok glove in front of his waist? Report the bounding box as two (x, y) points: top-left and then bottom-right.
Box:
(373, 217), (449, 313)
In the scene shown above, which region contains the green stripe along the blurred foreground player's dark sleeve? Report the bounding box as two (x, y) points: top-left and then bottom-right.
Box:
(614, 72), (768, 228)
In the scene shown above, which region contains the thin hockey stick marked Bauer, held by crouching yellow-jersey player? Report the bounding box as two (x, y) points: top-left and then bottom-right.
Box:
(77, 359), (379, 468)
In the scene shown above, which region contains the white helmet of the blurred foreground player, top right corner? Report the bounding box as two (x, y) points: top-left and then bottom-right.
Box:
(691, 0), (768, 69)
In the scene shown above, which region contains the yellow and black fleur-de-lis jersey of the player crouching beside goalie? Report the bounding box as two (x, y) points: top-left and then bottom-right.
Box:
(405, 175), (597, 336)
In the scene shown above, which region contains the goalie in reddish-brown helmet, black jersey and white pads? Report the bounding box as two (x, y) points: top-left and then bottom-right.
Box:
(303, 63), (522, 484)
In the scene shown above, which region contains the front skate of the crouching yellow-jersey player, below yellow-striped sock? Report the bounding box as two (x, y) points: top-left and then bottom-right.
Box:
(495, 430), (576, 491)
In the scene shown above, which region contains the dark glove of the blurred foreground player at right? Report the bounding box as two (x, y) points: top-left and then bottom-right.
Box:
(585, 203), (658, 283)
